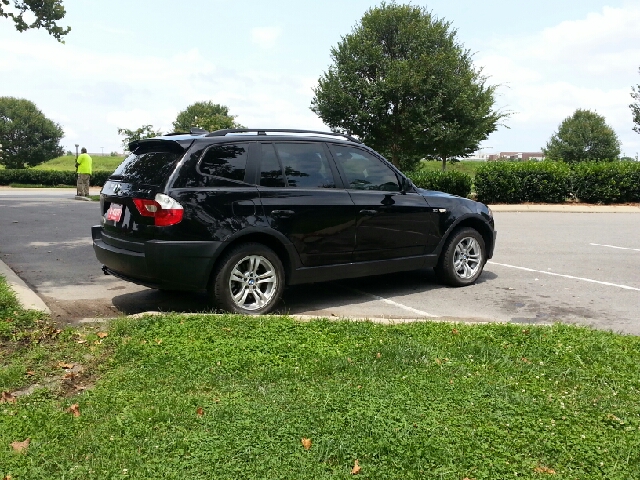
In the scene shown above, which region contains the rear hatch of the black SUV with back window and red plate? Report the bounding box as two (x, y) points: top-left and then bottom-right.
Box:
(100, 139), (190, 244)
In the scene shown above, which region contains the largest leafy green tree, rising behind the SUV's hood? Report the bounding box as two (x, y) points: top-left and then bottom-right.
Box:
(311, 3), (508, 170)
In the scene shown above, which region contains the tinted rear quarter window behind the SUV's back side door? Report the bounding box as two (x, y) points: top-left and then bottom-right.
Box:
(196, 143), (249, 187)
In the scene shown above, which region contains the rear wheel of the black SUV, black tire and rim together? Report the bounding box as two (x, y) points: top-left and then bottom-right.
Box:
(210, 243), (284, 315)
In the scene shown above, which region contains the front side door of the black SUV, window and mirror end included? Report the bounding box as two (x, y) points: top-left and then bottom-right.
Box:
(331, 144), (434, 262)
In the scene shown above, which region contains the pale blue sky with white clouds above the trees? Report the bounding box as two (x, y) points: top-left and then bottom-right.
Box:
(0, 0), (640, 157)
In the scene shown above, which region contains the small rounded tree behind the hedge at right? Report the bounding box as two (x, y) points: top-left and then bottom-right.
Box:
(542, 109), (620, 163)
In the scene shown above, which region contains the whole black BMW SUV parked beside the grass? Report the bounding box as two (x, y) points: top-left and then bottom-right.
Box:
(92, 129), (496, 314)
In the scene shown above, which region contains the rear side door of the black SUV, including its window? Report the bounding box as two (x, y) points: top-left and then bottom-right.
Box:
(258, 141), (355, 266)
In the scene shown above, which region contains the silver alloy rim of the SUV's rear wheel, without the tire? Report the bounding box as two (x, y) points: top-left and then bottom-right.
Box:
(229, 255), (278, 310)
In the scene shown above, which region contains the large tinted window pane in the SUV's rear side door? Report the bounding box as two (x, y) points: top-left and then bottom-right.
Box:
(275, 143), (336, 188)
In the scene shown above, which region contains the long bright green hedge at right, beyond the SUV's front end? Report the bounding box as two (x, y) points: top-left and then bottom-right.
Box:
(475, 162), (640, 203)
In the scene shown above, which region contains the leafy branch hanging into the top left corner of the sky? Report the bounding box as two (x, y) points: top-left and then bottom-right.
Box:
(0, 0), (71, 43)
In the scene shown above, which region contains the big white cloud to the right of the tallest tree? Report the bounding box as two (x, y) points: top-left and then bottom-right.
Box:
(477, 5), (640, 153)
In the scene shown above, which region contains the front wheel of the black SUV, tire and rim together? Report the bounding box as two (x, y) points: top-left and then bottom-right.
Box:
(436, 227), (487, 287)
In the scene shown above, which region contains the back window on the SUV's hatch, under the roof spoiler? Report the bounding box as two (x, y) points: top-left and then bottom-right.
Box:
(110, 151), (182, 186)
